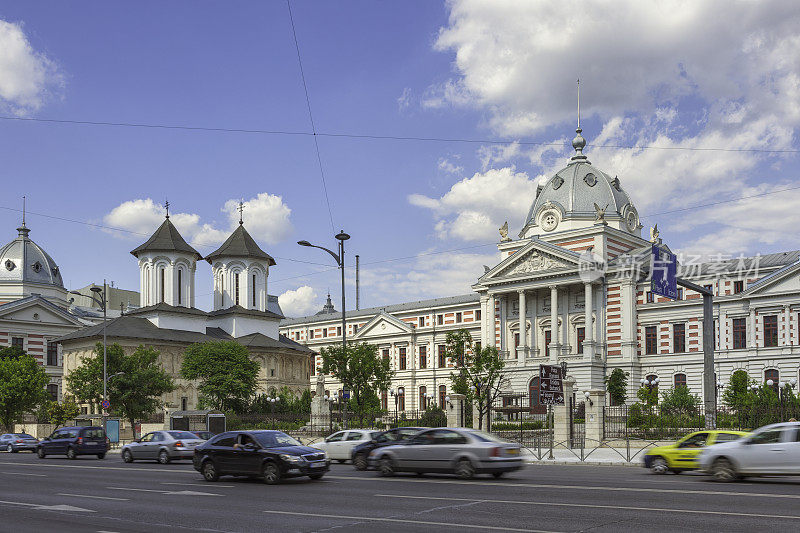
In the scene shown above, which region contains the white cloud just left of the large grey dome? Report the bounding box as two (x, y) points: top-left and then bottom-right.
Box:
(408, 167), (536, 241)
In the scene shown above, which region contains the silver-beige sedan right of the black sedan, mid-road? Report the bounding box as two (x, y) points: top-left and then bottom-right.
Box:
(369, 428), (523, 479)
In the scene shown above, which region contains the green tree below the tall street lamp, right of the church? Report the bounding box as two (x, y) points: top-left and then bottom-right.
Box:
(320, 342), (394, 413)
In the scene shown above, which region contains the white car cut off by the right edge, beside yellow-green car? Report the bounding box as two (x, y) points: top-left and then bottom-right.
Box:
(699, 422), (800, 481)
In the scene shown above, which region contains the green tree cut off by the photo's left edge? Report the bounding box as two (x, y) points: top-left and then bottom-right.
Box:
(0, 347), (50, 432)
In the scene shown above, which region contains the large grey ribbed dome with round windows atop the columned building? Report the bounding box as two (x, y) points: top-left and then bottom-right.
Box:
(520, 129), (642, 238)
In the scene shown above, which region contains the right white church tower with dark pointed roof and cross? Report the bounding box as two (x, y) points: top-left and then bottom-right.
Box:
(206, 204), (275, 311)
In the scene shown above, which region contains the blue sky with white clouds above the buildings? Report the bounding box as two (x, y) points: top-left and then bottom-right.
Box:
(0, 0), (800, 316)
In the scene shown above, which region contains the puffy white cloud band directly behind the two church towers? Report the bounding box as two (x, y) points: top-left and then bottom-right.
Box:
(103, 193), (293, 247)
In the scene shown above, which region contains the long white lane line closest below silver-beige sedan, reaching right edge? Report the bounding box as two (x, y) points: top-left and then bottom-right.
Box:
(326, 476), (800, 500)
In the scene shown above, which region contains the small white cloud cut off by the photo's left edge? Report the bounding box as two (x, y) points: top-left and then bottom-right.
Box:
(0, 20), (64, 115)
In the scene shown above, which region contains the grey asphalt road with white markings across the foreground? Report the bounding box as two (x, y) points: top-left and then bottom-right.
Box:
(0, 453), (800, 533)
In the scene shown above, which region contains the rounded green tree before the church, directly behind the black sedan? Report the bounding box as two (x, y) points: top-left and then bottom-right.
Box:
(181, 341), (259, 412)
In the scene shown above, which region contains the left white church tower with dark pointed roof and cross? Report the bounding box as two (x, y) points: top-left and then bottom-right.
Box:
(131, 205), (203, 307)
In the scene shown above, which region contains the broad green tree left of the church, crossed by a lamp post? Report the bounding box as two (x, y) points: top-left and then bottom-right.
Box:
(67, 342), (175, 434)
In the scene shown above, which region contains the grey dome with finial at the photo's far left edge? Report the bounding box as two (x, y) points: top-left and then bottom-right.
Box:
(0, 224), (64, 289)
